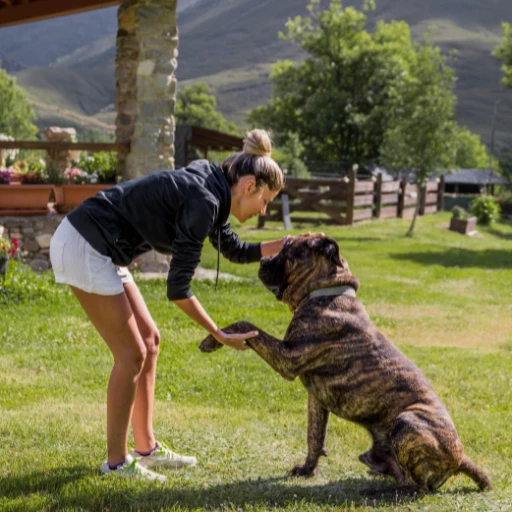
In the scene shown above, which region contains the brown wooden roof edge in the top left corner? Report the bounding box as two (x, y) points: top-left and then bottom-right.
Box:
(0, 0), (119, 27)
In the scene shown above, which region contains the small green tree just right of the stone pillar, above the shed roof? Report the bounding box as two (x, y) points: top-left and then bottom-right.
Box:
(175, 82), (238, 135)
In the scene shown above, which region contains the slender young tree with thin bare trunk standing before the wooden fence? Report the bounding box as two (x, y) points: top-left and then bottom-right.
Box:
(381, 40), (461, 236)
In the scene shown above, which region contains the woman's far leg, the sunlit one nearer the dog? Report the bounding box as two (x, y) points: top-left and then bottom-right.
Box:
(124, 283), (160, 453)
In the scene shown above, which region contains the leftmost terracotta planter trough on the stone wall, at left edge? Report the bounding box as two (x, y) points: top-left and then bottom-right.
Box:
(0, 184), (52, 215)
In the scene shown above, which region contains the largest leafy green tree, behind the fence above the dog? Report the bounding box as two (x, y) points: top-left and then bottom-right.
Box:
(249, 0), (414, 166)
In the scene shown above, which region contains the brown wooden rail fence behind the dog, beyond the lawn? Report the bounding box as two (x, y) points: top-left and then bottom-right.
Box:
(258, 174), (444, 227)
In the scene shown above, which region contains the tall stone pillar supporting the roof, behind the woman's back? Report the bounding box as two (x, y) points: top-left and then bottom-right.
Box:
(116, 0), (178, 180)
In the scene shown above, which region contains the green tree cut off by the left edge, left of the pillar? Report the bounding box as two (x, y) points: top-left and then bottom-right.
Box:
(0, 69), (37, 139)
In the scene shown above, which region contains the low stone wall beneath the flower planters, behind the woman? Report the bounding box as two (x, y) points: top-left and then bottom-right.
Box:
(0, 213), (170, 272)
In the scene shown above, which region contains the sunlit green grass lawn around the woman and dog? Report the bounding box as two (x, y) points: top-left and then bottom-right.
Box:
(0, 214), (512, 512)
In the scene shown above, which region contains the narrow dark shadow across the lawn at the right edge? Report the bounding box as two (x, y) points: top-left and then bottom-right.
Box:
(390, 249), (512, 269)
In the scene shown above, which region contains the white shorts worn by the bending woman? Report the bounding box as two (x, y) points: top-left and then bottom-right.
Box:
(50, 218), (133, 295)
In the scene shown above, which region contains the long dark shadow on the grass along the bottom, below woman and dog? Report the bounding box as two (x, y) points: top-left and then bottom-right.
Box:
(0, 467), (432, 512)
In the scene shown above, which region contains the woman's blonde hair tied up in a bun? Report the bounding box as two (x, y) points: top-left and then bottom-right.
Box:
(221, 130), (284, 191)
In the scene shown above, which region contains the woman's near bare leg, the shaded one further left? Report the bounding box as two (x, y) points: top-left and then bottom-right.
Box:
(71, 286), (146, 465)
